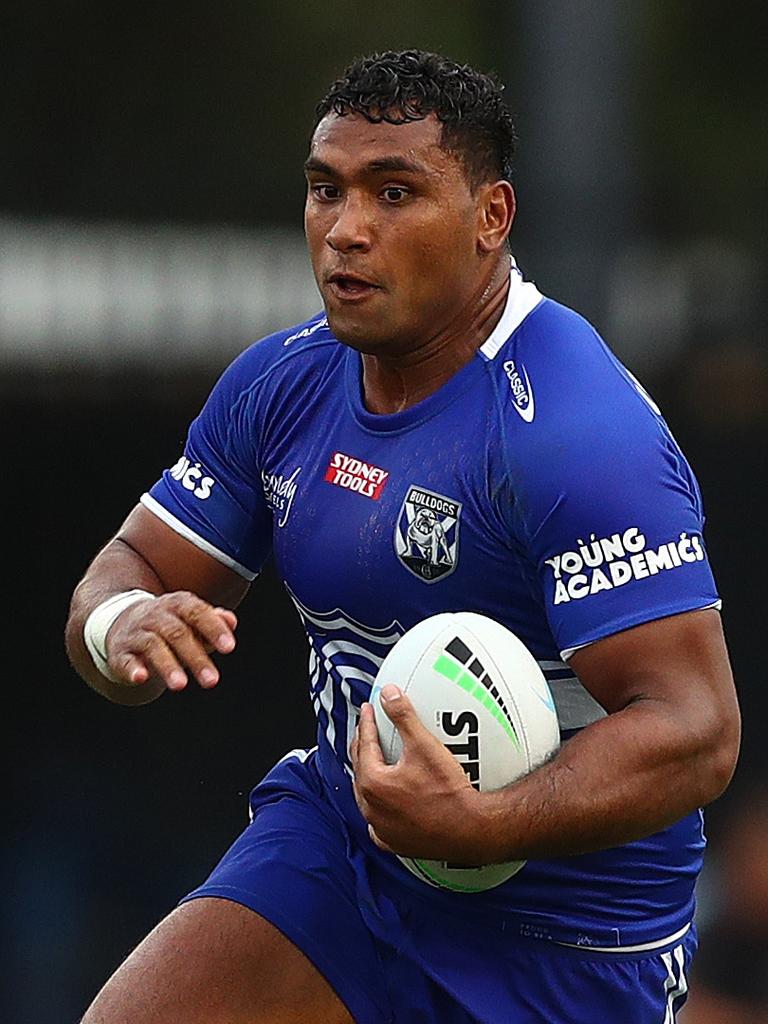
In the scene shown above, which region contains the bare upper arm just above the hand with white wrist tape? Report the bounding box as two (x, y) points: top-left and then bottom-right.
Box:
(118, 505), (249, 608)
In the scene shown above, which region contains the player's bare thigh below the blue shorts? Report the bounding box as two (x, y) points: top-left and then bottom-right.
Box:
(83, 898), (352, 1024)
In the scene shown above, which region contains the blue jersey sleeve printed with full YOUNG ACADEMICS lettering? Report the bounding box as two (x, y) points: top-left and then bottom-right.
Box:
(515, 305), (719, 657)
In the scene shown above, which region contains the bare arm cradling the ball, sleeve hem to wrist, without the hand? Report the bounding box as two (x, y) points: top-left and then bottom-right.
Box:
(481, 610), (739, 857)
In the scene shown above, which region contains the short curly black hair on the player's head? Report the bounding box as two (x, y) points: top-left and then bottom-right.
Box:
(312, 50), (516, 189)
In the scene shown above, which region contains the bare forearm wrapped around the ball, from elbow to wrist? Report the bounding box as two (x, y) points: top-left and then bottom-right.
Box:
(478, 699), (737, 861)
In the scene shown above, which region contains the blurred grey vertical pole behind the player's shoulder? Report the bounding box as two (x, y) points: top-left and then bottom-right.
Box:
(505, 0), (645, 323)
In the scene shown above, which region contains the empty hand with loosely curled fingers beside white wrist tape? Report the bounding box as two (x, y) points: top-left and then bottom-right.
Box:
(106, 591), (238, 690)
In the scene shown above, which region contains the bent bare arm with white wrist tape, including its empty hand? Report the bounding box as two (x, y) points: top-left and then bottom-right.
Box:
(66, 505), (248, 705)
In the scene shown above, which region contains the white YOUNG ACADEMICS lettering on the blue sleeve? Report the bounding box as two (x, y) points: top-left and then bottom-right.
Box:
(545, 526), (706, 604)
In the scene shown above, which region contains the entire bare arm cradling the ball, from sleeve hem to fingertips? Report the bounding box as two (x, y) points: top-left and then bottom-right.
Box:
(356, 610), (739, 863)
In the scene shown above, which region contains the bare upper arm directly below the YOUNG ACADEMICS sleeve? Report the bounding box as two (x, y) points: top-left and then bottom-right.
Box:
(569, 608), (738, 726)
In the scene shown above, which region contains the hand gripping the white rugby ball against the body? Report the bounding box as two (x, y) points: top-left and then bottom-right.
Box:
(351, 684), (489, 864)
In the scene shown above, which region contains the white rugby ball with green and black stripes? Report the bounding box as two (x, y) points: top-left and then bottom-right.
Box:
(370, 611), (560, 893)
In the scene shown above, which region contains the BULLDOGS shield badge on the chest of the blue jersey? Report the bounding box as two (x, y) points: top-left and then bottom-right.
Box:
(394, 484), (462, 583)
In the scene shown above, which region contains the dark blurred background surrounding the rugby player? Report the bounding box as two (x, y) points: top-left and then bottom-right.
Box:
(0, 0), (768, 1024)
